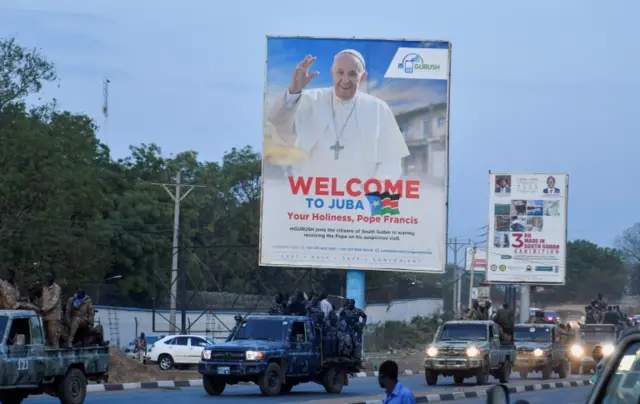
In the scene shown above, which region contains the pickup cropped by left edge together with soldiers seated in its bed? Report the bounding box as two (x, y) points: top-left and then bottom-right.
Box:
(0, 270), (109, 404)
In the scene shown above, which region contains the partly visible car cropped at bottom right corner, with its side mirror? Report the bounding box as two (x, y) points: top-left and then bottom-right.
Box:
(486, 328), (640, 404)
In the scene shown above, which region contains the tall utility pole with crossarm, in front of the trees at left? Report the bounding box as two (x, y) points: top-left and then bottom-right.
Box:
(153, 170), (204, 335)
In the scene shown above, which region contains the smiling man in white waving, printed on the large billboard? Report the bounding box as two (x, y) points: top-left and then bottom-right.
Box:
(265, 49), (409, 179)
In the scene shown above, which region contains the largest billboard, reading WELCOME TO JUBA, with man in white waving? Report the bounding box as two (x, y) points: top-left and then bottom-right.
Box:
(260, 37), (450, 273)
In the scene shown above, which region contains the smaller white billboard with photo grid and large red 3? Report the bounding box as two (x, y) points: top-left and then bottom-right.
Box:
(486, 174), (569, 285)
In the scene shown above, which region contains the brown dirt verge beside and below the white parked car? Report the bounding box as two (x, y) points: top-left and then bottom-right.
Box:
(109, 351), (200, 383)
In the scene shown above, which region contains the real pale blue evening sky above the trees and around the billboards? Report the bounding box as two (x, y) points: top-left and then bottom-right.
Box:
(0, 0), (640, 246)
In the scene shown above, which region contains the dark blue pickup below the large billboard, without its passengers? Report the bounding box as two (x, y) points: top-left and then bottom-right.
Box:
(198, 314), (362, 401)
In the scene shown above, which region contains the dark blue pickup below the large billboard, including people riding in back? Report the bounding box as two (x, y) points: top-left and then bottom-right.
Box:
(198, 292), (367, 396)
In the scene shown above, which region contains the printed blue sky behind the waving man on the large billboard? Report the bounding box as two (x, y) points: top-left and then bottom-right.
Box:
(265, 38), (448, 114)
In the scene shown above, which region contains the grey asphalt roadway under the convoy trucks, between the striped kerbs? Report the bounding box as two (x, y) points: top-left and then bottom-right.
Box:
(23, 374), (584, 404)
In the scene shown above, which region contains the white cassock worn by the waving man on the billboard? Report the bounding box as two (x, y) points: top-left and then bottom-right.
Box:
(268, 88), (409, 179)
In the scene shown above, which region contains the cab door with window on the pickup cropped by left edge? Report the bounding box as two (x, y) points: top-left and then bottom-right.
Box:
(5, 317), (38, 386)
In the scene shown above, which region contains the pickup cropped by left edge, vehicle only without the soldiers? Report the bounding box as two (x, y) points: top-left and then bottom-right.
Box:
(0, 310), (109, 404)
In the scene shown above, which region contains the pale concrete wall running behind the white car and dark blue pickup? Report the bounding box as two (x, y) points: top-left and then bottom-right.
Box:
(96, 299), (443, 347)
